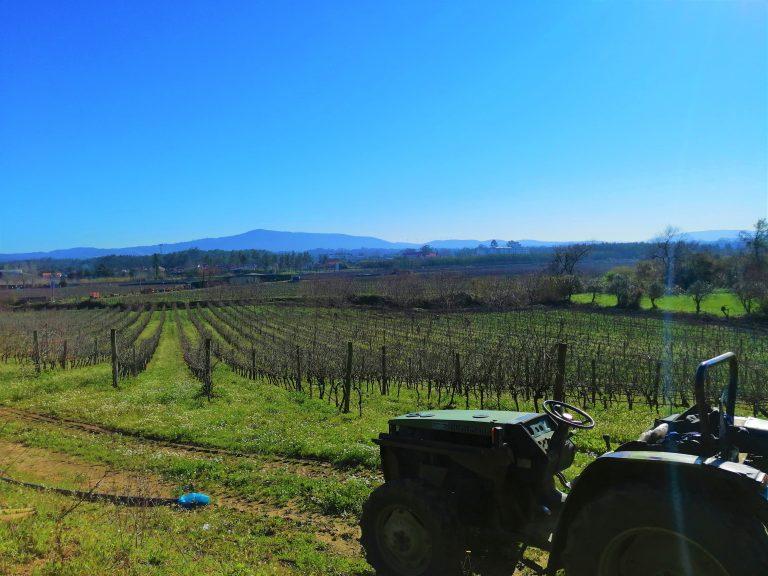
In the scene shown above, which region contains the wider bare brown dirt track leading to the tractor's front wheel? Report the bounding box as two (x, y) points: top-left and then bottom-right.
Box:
(0, 440), (361, 556)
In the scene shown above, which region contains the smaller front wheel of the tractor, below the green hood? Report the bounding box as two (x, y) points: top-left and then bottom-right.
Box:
(360, 480), (465, 576)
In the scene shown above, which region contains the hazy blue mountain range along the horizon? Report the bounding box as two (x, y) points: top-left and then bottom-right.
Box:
(0, 230), (740, 262)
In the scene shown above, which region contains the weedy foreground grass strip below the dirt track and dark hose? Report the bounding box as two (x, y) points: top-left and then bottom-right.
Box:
(0, 485), (370, 576)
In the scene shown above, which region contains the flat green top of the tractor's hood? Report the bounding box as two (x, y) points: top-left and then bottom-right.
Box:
(389, 410), (546, 436)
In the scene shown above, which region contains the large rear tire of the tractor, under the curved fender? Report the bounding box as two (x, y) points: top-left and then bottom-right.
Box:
(563, 484), (768, 576)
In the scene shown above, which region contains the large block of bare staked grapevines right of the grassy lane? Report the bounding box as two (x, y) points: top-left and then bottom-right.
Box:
(184, 304), (768, 407)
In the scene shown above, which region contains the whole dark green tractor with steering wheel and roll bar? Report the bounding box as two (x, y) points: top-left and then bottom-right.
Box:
(361, 352), (768, 576)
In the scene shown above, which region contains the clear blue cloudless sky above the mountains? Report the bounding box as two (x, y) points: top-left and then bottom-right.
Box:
(0, 0), (768, 252)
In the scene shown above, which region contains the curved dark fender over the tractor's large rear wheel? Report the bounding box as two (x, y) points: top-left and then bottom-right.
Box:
(547, 451), (768, 575)
